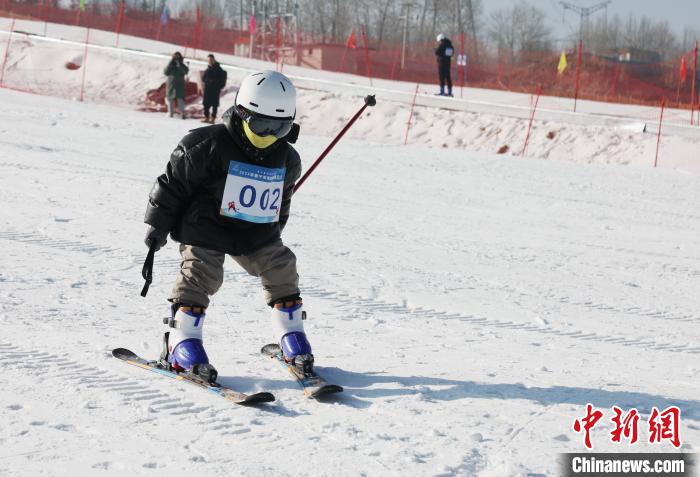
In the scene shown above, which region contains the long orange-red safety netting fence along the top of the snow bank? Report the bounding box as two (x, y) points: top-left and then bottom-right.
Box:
(0, 0), (700, 108)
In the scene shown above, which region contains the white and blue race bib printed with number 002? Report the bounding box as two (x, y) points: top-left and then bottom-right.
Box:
(220, 161), (286, 224)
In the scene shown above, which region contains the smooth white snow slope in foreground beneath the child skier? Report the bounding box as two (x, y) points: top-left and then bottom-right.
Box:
(0, 90), (700, 477)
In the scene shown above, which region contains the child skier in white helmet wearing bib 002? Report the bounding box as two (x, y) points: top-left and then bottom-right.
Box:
(144, 71), (313, 382)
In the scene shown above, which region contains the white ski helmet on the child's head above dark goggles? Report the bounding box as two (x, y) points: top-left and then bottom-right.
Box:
(234, 70), (297, 119)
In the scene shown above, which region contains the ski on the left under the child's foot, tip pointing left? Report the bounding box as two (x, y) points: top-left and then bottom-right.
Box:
(112, 348), (275, 406)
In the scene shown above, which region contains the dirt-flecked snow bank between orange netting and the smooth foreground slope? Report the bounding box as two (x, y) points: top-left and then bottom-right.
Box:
(0, 19), (700, 172)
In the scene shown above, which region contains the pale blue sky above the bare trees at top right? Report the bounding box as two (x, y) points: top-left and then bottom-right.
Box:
(482, 0), (700, 43)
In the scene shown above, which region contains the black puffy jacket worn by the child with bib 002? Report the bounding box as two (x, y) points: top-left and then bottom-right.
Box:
(144, 110), (301, 255)
